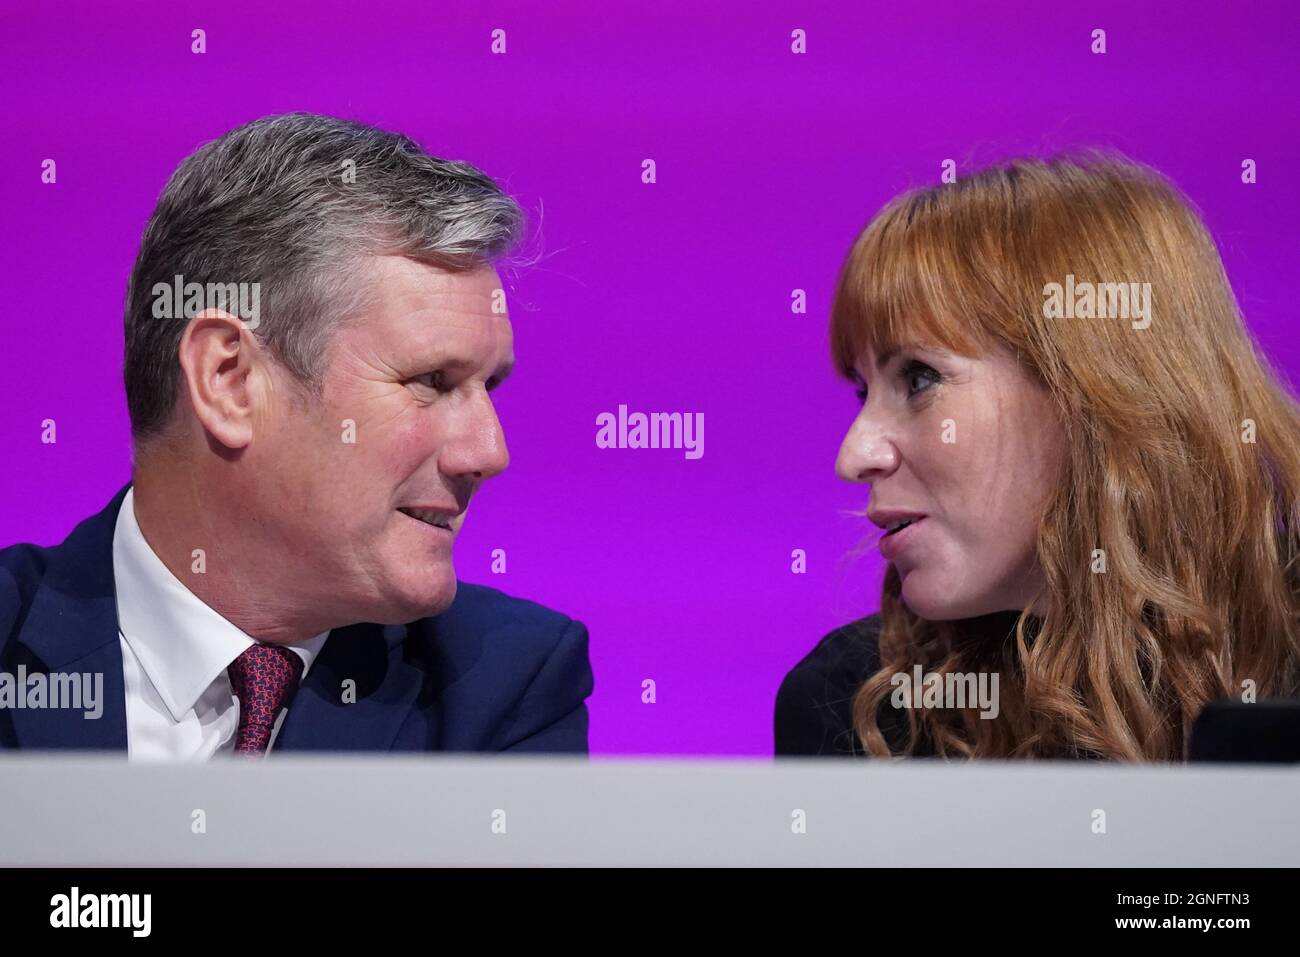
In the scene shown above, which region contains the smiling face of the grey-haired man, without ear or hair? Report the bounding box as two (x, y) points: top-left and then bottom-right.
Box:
(250, 256), (514, 624)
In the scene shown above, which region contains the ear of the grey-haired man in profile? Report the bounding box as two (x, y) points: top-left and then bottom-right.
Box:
(179, 309), (269, 449)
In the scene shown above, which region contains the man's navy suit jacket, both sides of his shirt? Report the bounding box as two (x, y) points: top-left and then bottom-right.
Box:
(0, 486), (594, 753)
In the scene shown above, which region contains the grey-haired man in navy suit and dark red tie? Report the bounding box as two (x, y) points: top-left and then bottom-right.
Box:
(0, 113), (593, 759)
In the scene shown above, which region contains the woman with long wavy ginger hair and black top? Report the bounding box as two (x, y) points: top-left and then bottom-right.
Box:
(776, 155), (1300, 761)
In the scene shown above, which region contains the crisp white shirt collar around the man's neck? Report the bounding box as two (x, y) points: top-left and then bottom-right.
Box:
(113, 489), (329, 720)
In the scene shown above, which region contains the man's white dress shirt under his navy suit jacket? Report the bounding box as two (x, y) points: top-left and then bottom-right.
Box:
(113, 489), (329, 761)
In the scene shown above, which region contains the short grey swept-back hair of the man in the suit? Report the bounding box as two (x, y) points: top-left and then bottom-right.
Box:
(124, 113), (523, 443)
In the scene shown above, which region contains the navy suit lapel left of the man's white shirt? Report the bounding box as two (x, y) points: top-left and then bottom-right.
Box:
(3, 486), (130, 752)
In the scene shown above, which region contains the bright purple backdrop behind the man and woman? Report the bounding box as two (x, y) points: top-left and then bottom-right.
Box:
(0, 0), (1300, 754)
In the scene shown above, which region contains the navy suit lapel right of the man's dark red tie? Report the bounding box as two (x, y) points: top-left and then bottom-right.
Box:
(273, 624), (434, 752)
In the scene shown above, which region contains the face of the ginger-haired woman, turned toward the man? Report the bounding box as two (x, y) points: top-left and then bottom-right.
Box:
(836, 346), (1065, 620)
